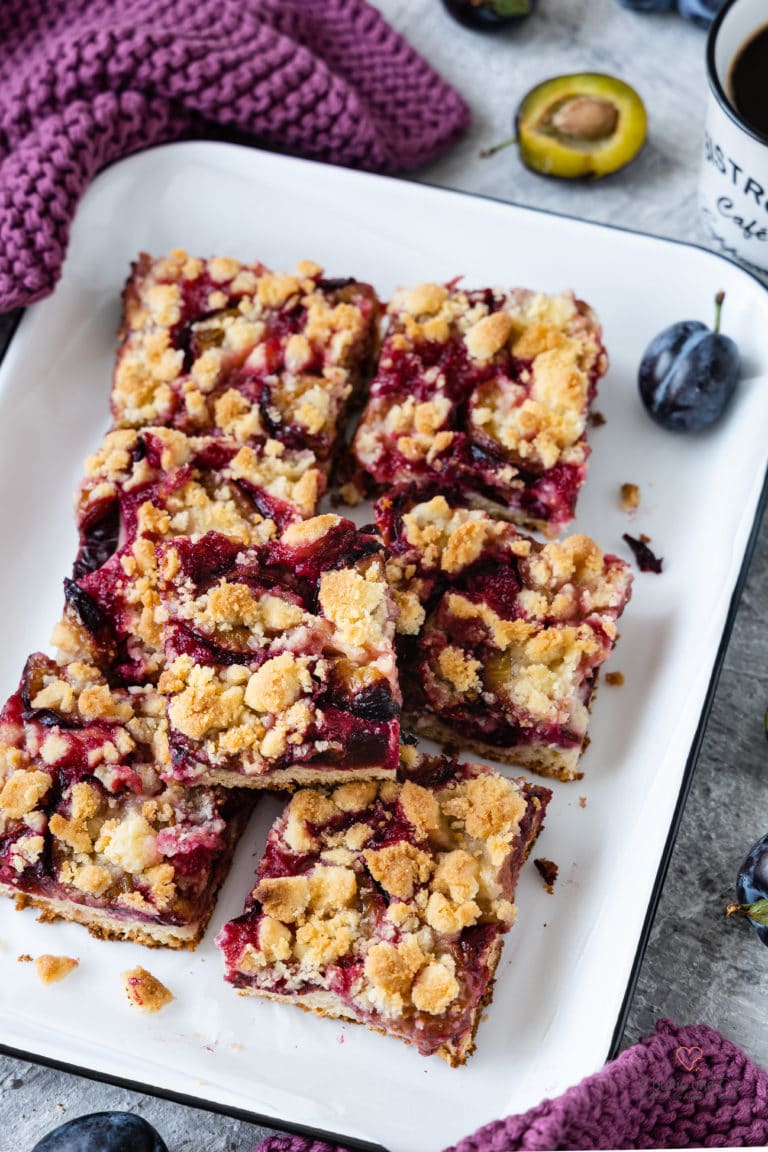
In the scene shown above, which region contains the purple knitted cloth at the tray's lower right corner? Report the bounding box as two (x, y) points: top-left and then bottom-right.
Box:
(254, 1020), (768, 1152)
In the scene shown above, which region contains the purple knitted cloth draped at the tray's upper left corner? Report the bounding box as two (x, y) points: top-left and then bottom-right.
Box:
(0, 0), (469, 311)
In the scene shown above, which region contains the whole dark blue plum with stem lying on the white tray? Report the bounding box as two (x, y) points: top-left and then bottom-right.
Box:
(638, 293), (740, 432)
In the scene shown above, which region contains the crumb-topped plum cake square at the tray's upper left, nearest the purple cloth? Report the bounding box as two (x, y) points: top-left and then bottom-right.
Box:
(112, 251), (379, 470)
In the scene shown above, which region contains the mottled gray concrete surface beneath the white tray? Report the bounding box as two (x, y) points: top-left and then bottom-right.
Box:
(0, 0), (768, 1152)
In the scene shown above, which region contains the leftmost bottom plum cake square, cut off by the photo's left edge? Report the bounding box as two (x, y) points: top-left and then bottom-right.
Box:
(0, 653), (252, 948)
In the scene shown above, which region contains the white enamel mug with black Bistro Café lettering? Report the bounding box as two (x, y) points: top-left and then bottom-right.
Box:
(699, 0), (768, 278)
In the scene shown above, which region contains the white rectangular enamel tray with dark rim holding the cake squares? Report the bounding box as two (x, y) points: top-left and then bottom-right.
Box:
(0, 143), (768, 1152)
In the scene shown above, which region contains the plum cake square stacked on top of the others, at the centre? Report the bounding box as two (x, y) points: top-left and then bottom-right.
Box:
(153, 515), (401, 788)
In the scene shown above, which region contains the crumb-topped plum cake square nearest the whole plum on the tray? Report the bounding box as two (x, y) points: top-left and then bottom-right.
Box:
(344, 285), (607, 536)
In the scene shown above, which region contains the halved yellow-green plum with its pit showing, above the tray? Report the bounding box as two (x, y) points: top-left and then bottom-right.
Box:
(516, 73), (647, 180)
